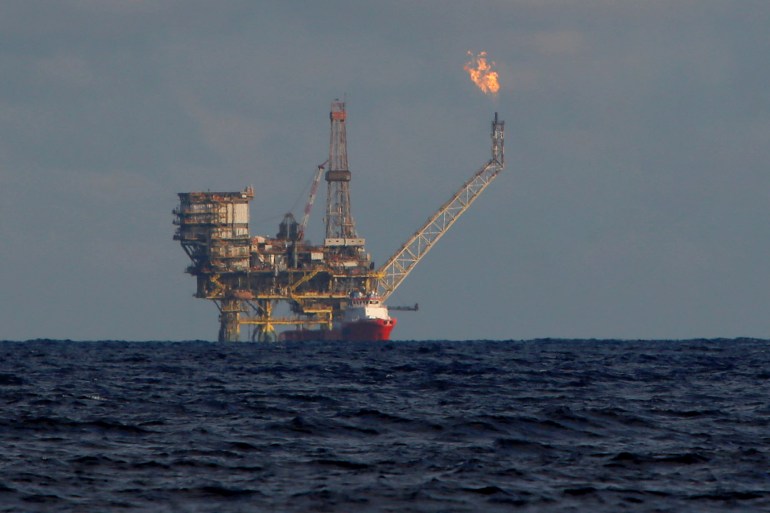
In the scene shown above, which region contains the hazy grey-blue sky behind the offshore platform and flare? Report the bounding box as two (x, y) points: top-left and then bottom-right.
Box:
(0, 0), (770, 340)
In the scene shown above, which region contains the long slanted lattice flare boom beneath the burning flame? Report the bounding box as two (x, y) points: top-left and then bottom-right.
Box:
(376, 113), (505, 301)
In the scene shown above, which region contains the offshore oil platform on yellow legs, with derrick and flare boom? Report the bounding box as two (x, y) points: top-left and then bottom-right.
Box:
(173, 100), (504, 341)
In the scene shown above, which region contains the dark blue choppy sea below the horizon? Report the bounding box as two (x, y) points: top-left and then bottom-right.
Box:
(0, 339), (770, 513)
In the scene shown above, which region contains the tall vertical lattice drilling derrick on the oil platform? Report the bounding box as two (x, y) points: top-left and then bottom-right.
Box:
(325, 100), (358, 246)
